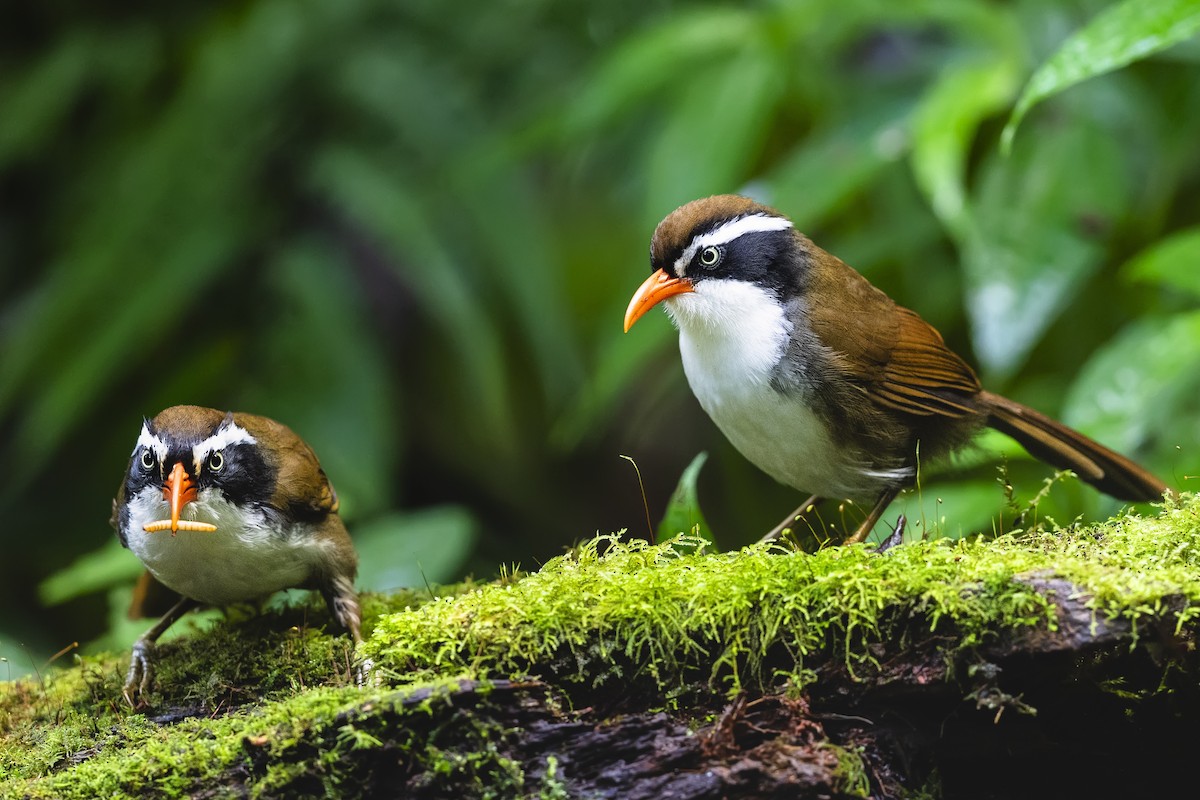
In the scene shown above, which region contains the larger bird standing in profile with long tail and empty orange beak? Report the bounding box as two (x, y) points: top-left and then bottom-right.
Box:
(624, 194), (1169, 542)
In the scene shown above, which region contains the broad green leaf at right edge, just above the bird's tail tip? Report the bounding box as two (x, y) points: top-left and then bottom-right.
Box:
(1063, 312), (1200, 462)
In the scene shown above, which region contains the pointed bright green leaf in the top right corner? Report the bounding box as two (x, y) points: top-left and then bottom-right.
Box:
(1001, 0), (1200, 152)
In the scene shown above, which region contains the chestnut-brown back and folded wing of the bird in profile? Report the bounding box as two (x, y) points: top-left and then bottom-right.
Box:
(802, 237), (980, 417)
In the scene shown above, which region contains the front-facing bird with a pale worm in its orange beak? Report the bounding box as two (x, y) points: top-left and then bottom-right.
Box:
(109, 405), (362, 705)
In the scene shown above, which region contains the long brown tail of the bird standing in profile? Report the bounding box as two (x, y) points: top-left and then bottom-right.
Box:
(978, 392), (1168, 501)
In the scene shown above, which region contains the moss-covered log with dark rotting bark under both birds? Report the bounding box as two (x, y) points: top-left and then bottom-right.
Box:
(0, 497), (1200, 798)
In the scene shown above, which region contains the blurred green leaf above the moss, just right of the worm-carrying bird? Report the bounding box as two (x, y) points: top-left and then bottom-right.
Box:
(350, 506), (479, 591)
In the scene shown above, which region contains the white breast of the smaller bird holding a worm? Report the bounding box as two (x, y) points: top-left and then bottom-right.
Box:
(126, 488), (322, 606)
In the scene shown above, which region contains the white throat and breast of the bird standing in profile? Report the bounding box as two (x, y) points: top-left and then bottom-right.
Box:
(665, 279), (898, 499)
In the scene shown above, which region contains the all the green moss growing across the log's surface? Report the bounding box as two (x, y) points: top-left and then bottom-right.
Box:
(0, 497), (1200, 798)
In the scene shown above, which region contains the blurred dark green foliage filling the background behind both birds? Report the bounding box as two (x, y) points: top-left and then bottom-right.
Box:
(0, 0), (1200, 679)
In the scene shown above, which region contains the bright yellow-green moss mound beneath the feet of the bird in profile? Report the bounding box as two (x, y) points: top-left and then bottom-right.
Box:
(364, 495), (1200, 692)
